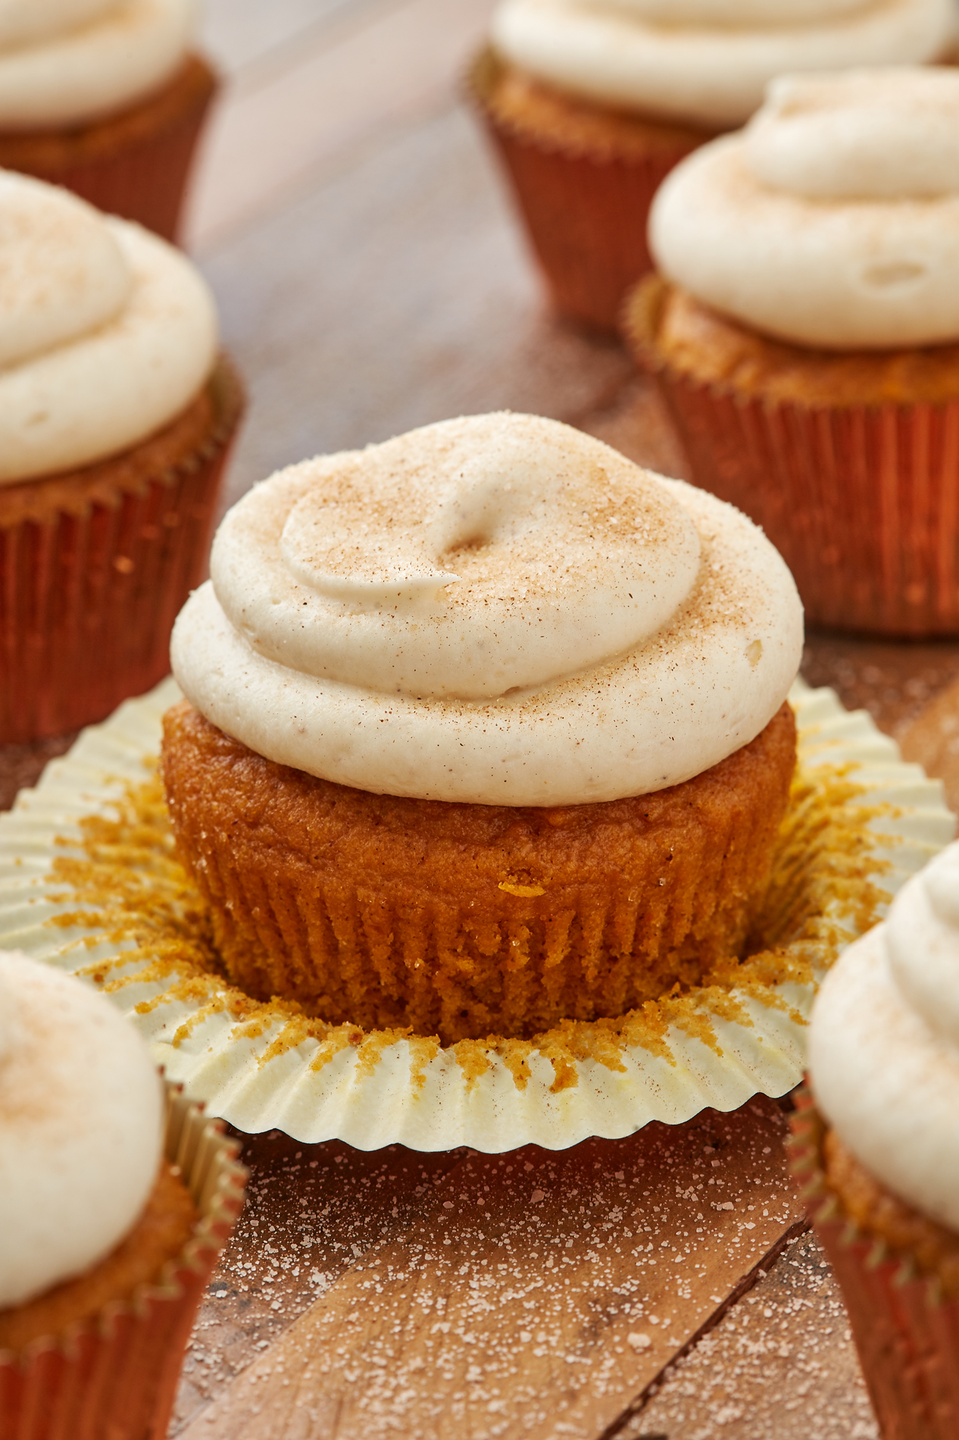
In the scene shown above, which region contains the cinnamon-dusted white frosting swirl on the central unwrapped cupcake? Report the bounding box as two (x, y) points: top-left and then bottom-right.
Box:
(171, 413), (802, 805)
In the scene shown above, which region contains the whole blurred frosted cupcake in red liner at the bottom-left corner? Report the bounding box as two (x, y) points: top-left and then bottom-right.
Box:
(0, 953), (245, 1440)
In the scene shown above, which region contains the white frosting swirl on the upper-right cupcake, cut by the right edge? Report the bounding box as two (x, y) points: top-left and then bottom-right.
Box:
(649, 66), (959, 350)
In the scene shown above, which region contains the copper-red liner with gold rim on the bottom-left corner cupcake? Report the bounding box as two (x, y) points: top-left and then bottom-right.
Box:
(0, 1086), (246, 1440)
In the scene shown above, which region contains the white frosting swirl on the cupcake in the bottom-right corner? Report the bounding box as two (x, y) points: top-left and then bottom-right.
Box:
(809, 844), (959, 1230)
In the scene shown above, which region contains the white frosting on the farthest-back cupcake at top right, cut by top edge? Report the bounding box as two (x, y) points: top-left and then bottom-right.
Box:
(492, 0), (956, 130)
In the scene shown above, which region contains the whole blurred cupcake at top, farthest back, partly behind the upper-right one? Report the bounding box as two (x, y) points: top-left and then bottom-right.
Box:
(471, 0), (956, 328)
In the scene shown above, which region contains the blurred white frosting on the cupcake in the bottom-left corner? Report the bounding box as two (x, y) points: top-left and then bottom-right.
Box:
(0, 952), (163, 1306)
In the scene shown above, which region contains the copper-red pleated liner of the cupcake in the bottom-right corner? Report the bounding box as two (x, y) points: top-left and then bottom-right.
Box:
(791, 1092), (959, 1440)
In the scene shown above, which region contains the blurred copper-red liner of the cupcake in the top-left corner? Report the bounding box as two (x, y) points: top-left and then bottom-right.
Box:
(0, 56), (219, 240)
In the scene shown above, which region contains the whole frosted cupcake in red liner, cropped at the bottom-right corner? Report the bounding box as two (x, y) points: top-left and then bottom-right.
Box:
(793, 844), (959, 1440)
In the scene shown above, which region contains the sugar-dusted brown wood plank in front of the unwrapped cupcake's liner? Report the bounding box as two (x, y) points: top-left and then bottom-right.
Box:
(184, 1099), (802, 1440)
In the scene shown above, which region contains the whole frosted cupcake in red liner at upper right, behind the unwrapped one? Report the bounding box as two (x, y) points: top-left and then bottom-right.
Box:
(626, 68), (959, 636)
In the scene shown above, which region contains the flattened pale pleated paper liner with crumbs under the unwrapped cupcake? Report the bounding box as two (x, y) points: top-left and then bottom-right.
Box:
(0, 681), (955, 1152)
